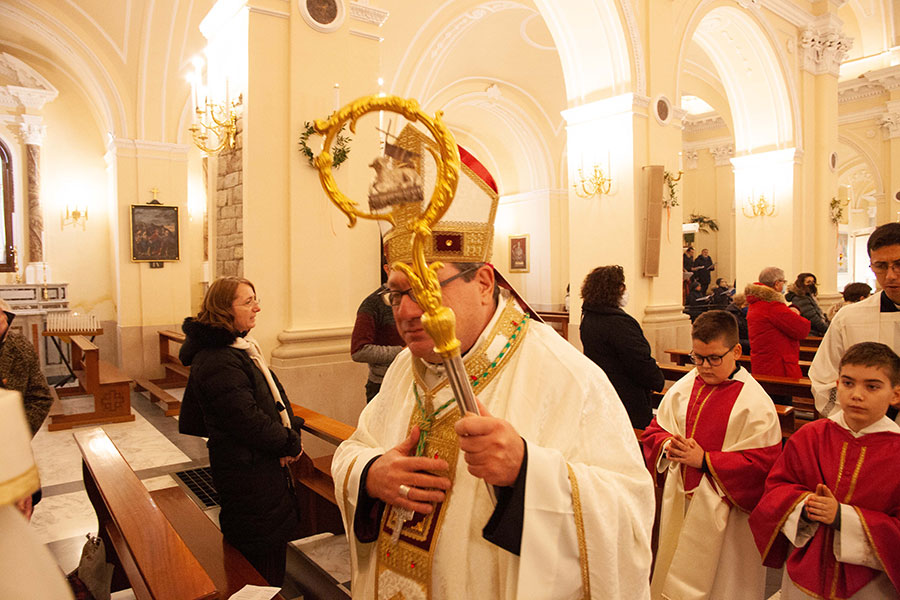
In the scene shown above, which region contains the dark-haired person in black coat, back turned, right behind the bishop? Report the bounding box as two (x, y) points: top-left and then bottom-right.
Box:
(581, 265), (666, 429)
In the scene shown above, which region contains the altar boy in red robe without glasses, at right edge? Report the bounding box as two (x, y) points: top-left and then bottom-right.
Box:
(750, 342), (900, 600)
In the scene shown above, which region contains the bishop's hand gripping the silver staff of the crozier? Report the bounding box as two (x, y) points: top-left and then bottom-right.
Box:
(456, 400), (525, 486)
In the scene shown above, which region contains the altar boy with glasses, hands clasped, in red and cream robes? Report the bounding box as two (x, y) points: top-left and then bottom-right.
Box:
(641, 310), (781, 600)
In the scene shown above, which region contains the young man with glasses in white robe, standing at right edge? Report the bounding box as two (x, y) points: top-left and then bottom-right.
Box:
(809, 223), (900, 418)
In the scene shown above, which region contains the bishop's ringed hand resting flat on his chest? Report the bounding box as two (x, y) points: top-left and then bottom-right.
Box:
(366, 427), (450, 514)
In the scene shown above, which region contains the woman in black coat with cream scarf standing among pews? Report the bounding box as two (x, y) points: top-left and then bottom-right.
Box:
(178, 277), (303, 587)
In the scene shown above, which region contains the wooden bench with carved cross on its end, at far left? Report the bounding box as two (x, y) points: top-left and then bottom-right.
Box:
(47, 335), (134, 431)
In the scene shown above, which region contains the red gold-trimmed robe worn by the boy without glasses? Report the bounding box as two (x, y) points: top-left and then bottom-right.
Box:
(750, 419), (900, 598)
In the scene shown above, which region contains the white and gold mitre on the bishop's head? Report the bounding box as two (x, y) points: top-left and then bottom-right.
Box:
(369, 125), (499, 264)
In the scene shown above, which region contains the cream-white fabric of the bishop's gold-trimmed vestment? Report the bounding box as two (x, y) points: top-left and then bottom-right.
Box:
(332, 300), (654, 600)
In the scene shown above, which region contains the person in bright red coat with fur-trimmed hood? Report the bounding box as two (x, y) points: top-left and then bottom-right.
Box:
(745, 267), (810, 379)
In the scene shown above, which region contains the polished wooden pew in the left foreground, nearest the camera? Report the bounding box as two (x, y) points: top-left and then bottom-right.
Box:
(75, 428), (283, 600)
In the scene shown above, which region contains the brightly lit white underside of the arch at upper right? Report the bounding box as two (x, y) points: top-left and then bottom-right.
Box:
(675, 0), (802, 154)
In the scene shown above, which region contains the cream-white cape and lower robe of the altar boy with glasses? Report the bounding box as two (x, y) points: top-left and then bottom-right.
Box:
(653, 367), (781, 600)
